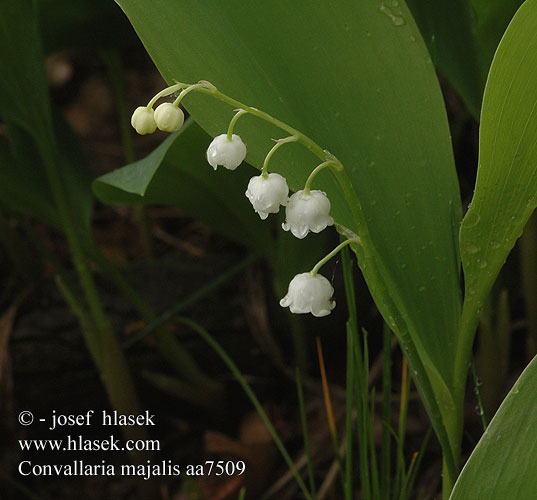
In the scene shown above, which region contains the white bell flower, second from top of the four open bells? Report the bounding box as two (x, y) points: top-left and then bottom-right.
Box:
(246, 174), (289, 220)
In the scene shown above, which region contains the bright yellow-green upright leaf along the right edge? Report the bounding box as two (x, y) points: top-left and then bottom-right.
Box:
(460, 0), (537, 340)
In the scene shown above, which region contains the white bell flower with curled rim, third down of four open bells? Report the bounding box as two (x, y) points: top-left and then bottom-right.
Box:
(282, 190), (334, 239)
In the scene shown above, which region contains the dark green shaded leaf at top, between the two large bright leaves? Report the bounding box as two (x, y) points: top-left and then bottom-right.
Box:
(407, 0), (486, 117)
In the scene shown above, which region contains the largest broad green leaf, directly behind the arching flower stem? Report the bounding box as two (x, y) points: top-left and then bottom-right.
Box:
(118, 0), (461, 460)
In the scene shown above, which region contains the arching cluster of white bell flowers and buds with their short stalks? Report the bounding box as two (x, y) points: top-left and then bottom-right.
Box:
(131, 81), (359, 317)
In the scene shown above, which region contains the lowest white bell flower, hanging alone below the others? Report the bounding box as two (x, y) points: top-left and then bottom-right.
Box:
(280, 273), (336, 318)
